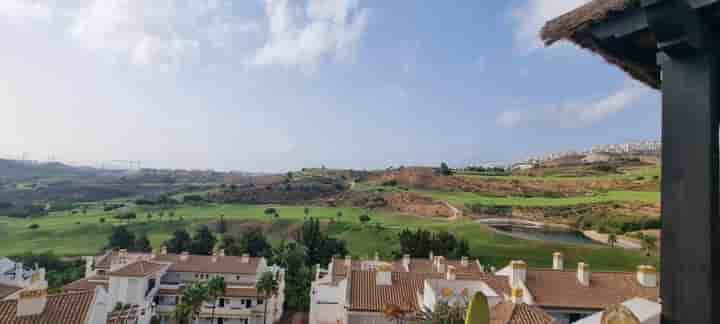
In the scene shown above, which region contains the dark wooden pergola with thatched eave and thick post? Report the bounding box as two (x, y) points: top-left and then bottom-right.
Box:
(541, 0), (720, 324)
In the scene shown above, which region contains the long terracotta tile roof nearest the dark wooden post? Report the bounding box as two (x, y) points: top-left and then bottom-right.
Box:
(526, 269), (660, 310)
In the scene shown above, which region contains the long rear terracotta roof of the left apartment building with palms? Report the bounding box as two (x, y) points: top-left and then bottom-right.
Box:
(153, 254), (261, 274)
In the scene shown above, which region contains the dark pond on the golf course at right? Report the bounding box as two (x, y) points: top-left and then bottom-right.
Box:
(489, 224), (597, 244)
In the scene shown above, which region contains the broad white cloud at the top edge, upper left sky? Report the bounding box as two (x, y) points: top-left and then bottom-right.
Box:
(69, 0), (240, 65)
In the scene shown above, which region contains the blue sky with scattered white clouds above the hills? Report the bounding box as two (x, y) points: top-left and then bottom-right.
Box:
(0, 0), (660, 171)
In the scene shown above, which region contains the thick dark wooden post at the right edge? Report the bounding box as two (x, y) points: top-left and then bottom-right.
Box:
(660, 48), (720, 324)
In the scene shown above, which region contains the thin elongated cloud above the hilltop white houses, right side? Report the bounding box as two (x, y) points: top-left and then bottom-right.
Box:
(496, 81), (649, 128)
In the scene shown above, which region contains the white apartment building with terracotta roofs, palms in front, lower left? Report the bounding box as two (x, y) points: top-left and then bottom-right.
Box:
(64, 247), (285, 324)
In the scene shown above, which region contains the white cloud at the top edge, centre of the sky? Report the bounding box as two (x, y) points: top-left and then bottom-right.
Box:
(247, 0), (368, 67)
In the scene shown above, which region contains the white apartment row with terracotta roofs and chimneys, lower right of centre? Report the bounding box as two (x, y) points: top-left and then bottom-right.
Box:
(310, 253), (659, 324)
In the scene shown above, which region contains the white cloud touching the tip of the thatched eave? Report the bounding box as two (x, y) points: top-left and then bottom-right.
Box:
(510, 0), (587, 53)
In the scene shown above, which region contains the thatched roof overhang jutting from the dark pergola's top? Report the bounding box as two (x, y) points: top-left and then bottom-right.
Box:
(540, 0), (660, 89)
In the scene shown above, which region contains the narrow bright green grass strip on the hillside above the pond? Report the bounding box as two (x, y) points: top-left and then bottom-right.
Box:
(412, 190), (660, 207)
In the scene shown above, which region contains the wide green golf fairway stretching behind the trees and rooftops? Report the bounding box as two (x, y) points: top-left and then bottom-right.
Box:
(0, 204), (657, 270)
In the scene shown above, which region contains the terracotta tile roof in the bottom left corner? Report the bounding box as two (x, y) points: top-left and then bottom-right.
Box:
(0, 291), (95, 324)
